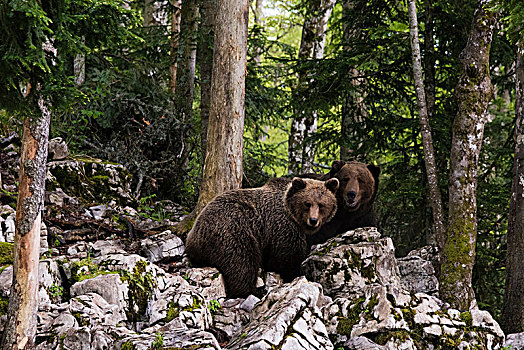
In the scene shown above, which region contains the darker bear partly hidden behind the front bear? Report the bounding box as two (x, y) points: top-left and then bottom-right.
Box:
(304, 160), (380, 245)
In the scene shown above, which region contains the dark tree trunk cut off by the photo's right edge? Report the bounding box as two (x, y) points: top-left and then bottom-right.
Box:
(501, 43), (524, 334)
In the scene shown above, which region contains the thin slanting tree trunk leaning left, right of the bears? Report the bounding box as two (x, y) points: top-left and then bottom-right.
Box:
(408, 0), (445, 252)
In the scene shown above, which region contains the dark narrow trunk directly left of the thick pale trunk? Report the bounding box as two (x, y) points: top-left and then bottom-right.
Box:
(198, 0), (216, 165)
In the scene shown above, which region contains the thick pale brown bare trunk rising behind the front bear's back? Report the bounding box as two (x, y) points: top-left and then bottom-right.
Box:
(196, 0), (249, 213)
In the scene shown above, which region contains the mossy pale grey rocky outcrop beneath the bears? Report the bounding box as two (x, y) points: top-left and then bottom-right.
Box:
(0, 140), (512, 350)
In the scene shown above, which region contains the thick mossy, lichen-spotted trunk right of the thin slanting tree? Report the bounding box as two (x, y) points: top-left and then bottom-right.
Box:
(440, 0), (497, 310)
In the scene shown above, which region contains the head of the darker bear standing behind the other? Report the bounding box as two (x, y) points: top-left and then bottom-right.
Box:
(329, 160), (380, 212)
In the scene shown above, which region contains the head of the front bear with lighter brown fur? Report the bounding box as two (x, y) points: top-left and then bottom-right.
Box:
(284, 177), (339, 235)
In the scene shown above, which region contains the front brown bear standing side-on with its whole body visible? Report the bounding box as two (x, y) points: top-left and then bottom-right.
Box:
(186, 178), (338, 298)
